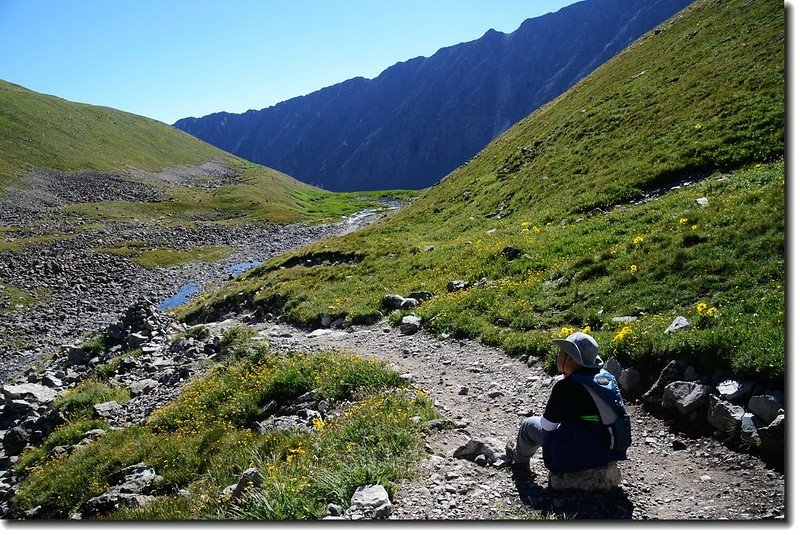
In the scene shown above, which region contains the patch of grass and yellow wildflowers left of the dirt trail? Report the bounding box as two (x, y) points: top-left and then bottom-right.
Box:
(14, 330), (438, 520)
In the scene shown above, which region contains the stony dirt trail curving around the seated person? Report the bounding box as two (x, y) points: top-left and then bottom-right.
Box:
(239, 318), (786, 520)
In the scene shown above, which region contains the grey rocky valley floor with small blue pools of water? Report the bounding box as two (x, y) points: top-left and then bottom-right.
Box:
(0, 197), (376, 383)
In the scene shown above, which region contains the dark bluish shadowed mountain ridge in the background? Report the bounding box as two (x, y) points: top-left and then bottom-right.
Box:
(175, 0), (691, 191)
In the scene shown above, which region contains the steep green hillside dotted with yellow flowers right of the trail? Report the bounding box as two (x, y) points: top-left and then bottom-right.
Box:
(187, 0), (785, 388)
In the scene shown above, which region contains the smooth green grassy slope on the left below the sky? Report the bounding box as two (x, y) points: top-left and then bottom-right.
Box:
(0, 80), (406, 224)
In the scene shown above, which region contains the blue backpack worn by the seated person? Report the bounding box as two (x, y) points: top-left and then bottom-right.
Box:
(570, 370), (631, 460)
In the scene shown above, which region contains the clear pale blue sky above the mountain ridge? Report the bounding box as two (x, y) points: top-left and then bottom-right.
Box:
(0, 0), (578, 123)
